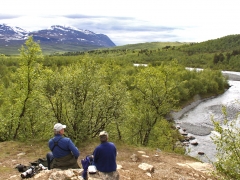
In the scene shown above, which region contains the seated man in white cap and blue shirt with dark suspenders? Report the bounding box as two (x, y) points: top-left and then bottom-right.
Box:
(47, 123), (80, 169)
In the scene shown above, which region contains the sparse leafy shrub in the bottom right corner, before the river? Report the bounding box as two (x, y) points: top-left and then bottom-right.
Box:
(212, 108), (240, 179)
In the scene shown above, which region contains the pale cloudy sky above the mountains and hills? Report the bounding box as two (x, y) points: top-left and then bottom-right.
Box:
(0, 0), (240, 46)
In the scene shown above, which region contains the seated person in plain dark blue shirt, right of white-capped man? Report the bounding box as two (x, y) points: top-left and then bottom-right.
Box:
(93, 131), (119, 180)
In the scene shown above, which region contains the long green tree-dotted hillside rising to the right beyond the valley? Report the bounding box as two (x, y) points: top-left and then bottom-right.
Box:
(44, 35), (240, 71)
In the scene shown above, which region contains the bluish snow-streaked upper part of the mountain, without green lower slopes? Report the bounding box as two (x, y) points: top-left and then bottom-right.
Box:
(0, 24), (115, 47)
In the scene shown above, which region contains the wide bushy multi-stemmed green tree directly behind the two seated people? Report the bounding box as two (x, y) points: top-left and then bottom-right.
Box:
(41, 57), (126, 141)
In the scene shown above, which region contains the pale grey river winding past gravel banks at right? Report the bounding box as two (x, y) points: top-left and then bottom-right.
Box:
(174, 71), (240, 162)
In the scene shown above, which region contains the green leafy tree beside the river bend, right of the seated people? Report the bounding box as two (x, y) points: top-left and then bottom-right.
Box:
(125, 62), (179, 146)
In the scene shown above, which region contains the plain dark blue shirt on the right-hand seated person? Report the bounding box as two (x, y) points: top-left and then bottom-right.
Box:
(93, 142), (117, 172)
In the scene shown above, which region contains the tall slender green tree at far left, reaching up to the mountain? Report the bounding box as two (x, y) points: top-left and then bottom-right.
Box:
(0, 37), (48, 140)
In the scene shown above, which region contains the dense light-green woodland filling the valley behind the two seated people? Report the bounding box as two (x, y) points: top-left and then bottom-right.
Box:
(0, 38), (227, 152)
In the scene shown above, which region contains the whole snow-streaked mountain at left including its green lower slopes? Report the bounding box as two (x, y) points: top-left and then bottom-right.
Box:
(0, 24), (116, 55)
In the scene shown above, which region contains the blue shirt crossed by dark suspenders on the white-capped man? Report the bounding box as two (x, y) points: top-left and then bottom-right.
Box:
(48, 134), (80, 159)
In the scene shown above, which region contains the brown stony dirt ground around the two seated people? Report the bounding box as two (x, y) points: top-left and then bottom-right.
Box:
(0, 141), (217, 180)
